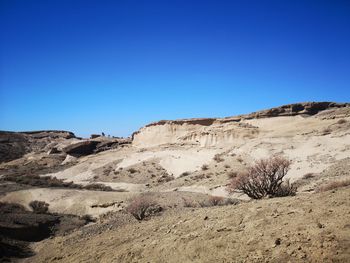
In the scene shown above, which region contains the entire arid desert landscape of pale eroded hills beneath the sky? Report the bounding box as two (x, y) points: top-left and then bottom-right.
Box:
(0, 102), (350, 262)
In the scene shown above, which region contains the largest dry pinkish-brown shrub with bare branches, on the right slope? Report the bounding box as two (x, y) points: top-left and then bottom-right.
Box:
(228, 156), (296, 199)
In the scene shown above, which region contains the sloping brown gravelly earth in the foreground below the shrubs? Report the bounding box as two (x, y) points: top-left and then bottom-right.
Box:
(25, 187), (350, 262)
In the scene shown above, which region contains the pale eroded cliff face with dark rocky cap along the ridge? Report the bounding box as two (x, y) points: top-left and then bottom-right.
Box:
(133, 102), (350, 147)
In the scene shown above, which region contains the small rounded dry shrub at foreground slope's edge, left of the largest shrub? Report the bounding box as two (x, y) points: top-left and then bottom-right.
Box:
(126, 195), (162, 220)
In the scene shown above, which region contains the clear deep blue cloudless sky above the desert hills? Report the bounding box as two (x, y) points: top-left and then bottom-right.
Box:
(0, 0), (350, 136)
